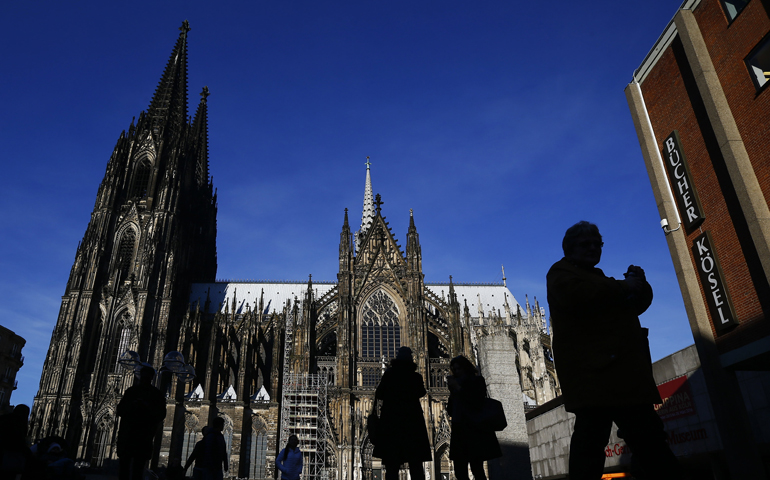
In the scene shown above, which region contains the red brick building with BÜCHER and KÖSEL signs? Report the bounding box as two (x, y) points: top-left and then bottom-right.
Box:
(626, 0), (770, 478)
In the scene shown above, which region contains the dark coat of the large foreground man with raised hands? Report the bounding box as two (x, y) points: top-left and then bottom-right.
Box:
(546, 258), (661, 412)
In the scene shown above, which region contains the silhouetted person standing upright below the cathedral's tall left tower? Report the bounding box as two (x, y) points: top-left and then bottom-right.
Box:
(118, 366), (166, 480)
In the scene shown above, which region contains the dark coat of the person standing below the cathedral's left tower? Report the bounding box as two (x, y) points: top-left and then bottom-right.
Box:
(117, 383), (166, 458)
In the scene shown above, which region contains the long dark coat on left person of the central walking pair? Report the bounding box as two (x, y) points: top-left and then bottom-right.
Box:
(372, 360), (432, 464)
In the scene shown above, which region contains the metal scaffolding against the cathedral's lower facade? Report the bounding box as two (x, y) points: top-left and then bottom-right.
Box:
(280, 306), (336, 480)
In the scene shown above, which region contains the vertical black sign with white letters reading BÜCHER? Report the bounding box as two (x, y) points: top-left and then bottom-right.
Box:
(663, 130), (705, 231)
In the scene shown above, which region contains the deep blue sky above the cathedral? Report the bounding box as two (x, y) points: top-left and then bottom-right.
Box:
(0, 0), (692, 410)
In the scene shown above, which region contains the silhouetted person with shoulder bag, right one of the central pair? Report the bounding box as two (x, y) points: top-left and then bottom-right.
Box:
(447, 355), (503, 480)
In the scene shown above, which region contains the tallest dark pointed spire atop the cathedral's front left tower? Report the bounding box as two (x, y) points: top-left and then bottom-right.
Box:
(148, 20), (190, 134)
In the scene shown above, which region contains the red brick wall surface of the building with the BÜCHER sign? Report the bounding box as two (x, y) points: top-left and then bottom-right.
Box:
(641, 0), (770, 353)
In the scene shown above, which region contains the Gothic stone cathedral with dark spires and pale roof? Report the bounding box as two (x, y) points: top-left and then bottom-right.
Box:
(30, 22), (559, 480)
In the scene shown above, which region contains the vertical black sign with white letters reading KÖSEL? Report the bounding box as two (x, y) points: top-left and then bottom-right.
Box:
(692, 231), (738, 334)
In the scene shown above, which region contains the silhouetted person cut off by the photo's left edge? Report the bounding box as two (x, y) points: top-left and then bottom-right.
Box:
(0, 405), (32, 480)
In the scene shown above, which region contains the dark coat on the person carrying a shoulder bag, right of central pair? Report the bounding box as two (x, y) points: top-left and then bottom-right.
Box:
(447, 375), (503, 461)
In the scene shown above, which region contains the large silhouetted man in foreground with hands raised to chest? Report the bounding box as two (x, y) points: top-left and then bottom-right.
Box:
(547, 222), (681, 480)
